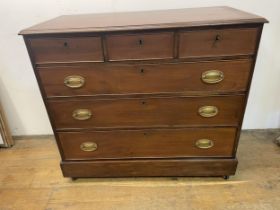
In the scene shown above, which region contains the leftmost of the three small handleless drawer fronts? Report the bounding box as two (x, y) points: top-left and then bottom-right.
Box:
(30, 37), (103, 63)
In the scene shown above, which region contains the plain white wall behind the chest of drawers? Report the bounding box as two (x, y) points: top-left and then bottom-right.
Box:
(0, 0), (280, 135)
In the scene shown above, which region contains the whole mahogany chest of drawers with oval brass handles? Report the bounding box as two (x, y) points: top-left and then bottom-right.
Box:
(20, 7), (267, 178)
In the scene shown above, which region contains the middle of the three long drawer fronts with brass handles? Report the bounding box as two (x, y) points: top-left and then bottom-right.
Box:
(48, 96), (244, 129)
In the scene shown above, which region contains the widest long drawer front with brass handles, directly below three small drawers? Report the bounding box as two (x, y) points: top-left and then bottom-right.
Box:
(37, 60), (252, 97)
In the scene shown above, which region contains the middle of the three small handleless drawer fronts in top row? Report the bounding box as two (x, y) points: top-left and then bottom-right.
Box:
(106, 32), (174, 60)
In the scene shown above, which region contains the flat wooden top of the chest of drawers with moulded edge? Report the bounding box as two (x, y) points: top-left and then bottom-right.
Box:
(20, 7), (267, 35)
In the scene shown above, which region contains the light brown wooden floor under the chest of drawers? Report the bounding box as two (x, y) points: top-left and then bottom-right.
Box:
(0, 131), (280, 210)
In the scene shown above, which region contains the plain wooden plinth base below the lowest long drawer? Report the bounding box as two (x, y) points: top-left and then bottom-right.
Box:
(61, 159), (237, 178)
